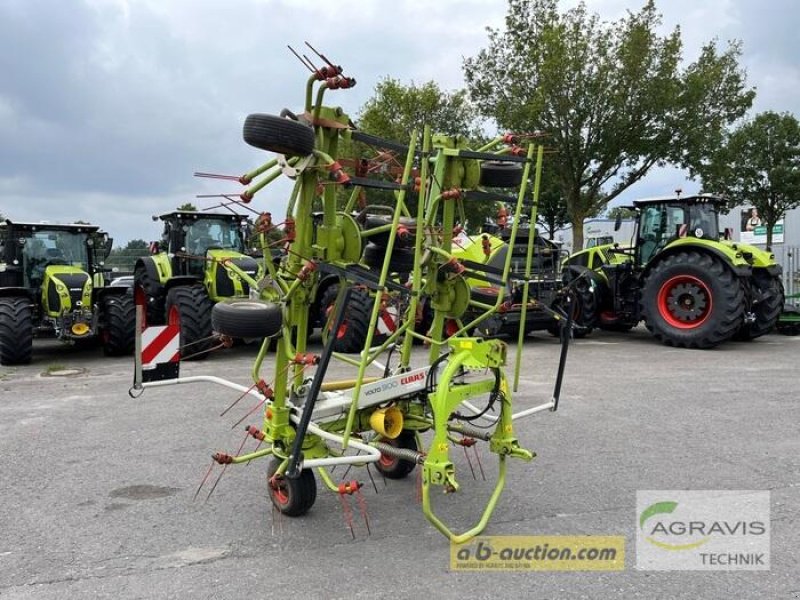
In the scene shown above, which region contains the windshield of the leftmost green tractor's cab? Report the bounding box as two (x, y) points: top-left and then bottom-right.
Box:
(22, 231), (89, 287)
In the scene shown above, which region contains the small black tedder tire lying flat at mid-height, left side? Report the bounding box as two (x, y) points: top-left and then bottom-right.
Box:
(211, 300), (283, 338)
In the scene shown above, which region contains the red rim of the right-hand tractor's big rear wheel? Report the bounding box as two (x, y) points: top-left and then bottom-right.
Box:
(658, 275), (713, 329)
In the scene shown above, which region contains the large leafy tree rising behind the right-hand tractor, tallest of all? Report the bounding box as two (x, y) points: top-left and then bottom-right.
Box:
(464, 0), (754, 248)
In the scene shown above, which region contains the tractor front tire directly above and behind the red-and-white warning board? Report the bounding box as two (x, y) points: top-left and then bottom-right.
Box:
(166, 284), (213, 360)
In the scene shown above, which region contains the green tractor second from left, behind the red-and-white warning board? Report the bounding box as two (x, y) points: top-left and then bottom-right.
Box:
(134, 210), (264, 359)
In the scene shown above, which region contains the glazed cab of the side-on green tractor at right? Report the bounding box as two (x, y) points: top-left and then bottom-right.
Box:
(634, 195), (724, 266)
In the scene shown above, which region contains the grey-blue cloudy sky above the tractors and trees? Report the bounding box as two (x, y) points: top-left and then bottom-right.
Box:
(0, 0), (800, 245)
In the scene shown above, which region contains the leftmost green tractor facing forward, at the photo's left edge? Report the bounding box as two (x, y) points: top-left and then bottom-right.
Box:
(0, 220), (135, 365)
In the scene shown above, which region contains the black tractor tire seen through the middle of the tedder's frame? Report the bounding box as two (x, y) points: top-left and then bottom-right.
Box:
(319, 285), (386, 354)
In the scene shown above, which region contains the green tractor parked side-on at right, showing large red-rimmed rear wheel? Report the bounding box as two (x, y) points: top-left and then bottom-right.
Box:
(564, 195), (784, 348)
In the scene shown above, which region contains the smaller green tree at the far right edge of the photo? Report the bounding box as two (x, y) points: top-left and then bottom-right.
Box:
(698, 111), (800, 248)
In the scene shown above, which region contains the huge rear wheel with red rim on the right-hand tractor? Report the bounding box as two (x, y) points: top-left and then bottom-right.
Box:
(642, 250), (744, 349)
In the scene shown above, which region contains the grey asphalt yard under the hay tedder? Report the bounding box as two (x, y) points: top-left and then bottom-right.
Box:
(0, 328), (800, 600)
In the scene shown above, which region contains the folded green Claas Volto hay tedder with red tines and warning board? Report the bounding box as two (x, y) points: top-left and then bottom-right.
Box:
(131, 46), (571, 543)
